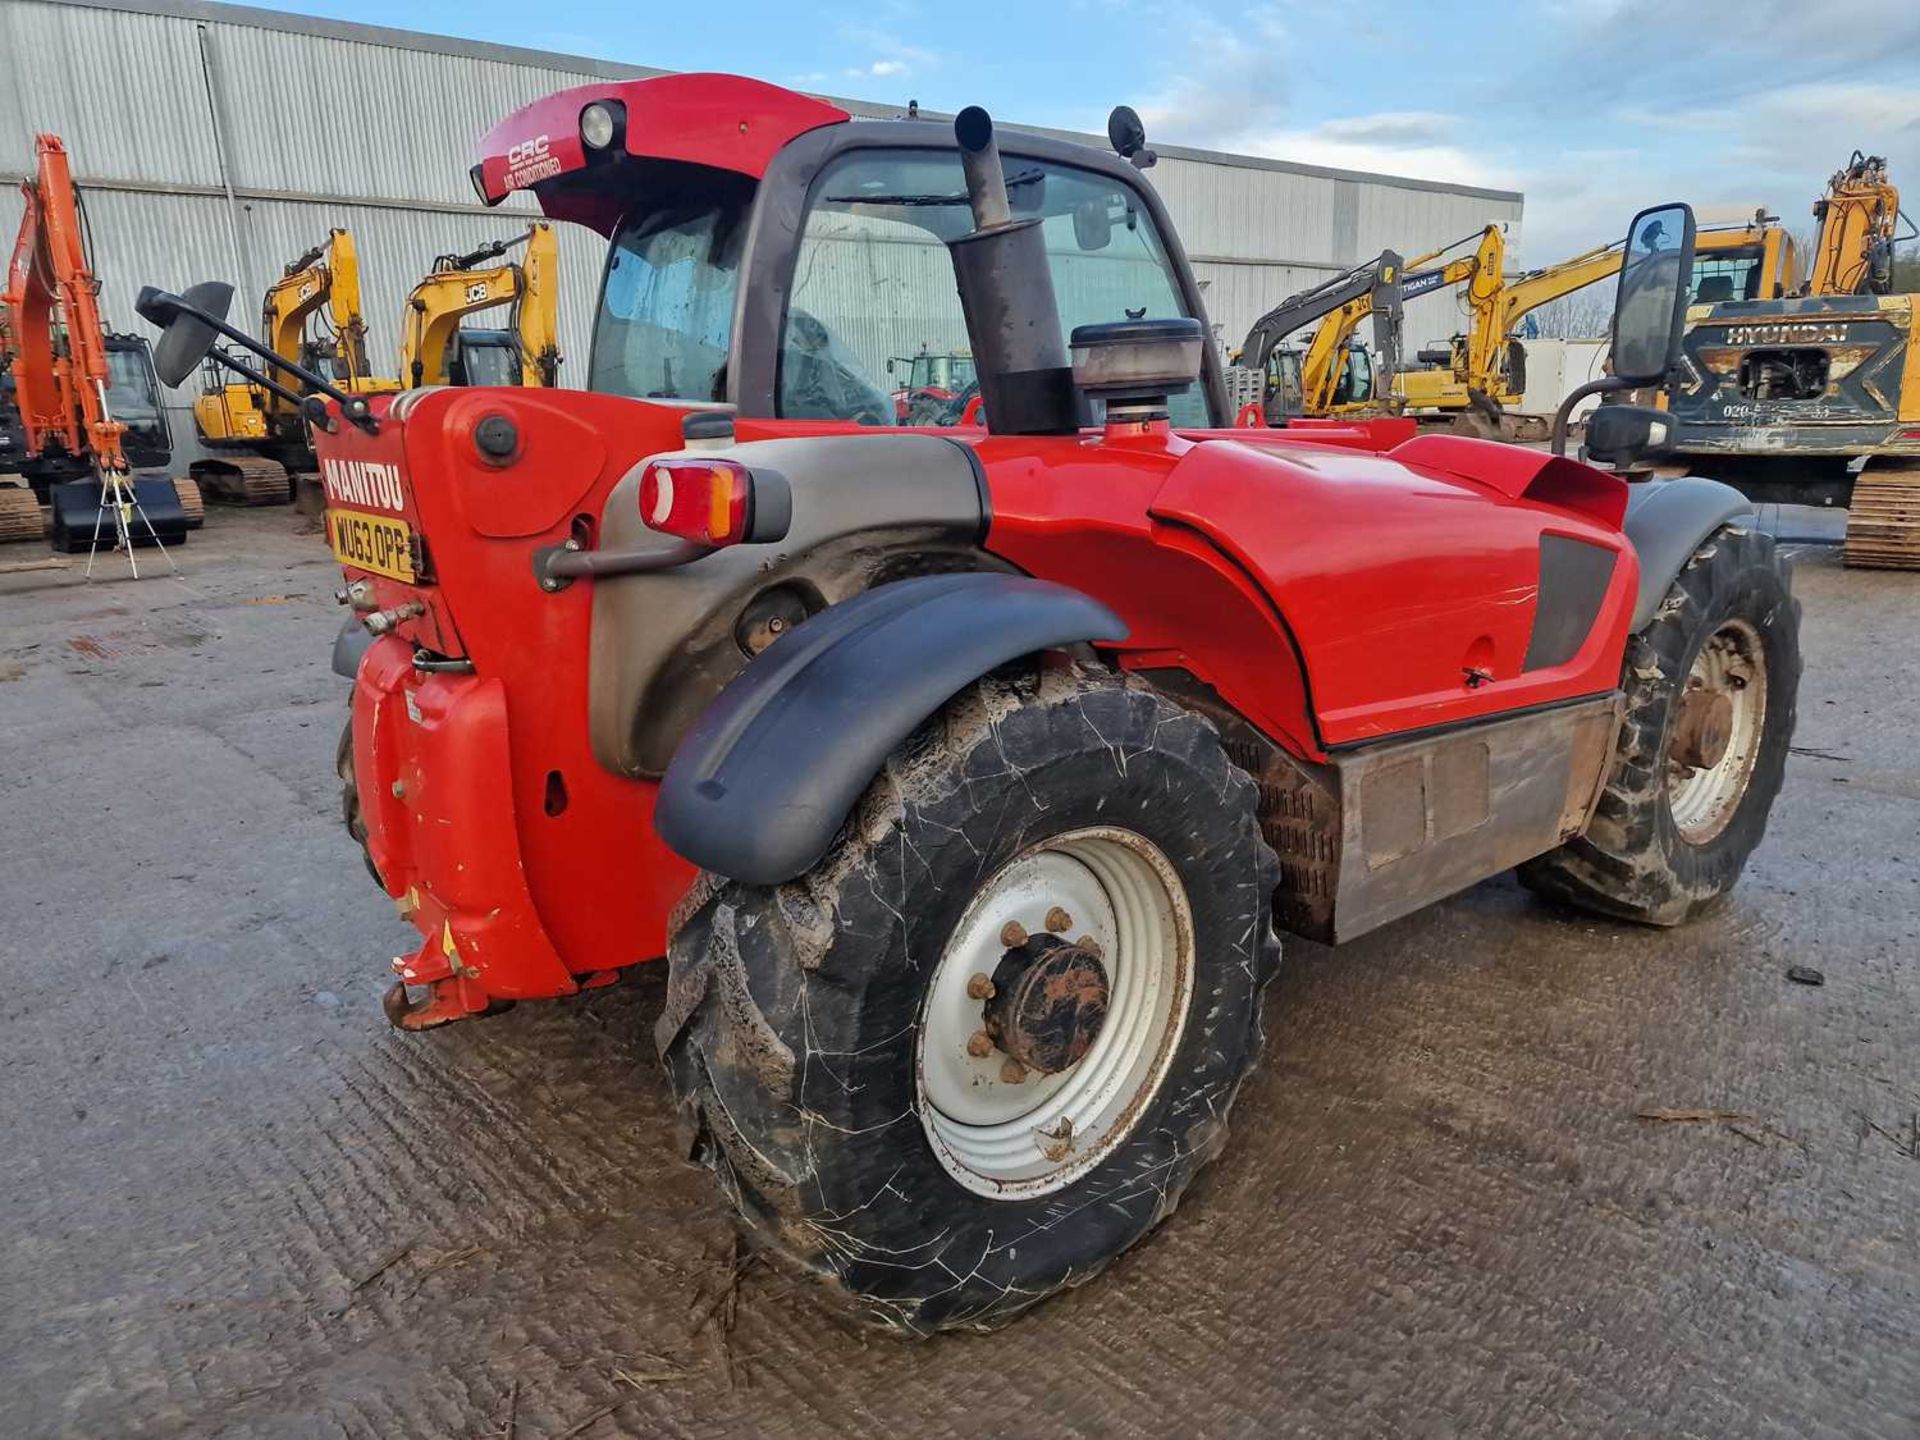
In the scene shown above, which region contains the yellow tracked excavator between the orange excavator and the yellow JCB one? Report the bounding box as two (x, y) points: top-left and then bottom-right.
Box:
(188, 228), (399, 505)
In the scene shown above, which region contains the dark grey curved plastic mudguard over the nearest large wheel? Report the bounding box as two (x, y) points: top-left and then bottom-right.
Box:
(653, 574), (1127, 885)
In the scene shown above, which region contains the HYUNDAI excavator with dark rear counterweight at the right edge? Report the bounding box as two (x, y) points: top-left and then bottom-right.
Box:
(1668, 152), (1920, 570)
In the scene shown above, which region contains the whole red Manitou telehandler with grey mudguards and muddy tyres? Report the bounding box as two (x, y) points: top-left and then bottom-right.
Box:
(142, 75), (1799, 1332)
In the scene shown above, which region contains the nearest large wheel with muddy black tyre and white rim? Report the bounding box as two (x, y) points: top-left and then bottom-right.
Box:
(659, 670), (1279, 1334)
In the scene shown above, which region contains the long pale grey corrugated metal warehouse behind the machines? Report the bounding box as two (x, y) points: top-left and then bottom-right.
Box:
(0, 0), (1521, 442)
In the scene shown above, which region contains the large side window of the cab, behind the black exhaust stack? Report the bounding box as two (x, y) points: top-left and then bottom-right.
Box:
(778, 150), (1210, 426)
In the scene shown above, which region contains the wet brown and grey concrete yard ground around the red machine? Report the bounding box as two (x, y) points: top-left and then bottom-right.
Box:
(0, 511), (1920, 1440)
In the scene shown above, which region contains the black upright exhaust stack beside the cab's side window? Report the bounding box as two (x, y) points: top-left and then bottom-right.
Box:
(948, 106), (1085, 436)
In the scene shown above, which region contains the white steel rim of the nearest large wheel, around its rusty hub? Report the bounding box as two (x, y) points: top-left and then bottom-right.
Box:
(914, 828), (1194, 1200)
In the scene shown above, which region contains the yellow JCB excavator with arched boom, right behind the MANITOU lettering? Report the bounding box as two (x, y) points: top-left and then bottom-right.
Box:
(399, 221), (561, 390)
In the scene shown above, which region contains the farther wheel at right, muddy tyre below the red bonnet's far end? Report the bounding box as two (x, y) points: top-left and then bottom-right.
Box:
(1521, 530), (1801, 925)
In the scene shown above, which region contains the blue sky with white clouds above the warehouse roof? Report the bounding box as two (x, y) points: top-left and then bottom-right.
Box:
(282, 0), (1920, 267)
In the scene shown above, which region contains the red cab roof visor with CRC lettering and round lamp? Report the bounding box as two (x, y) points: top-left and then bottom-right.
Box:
(472, 75), (852, 234)
